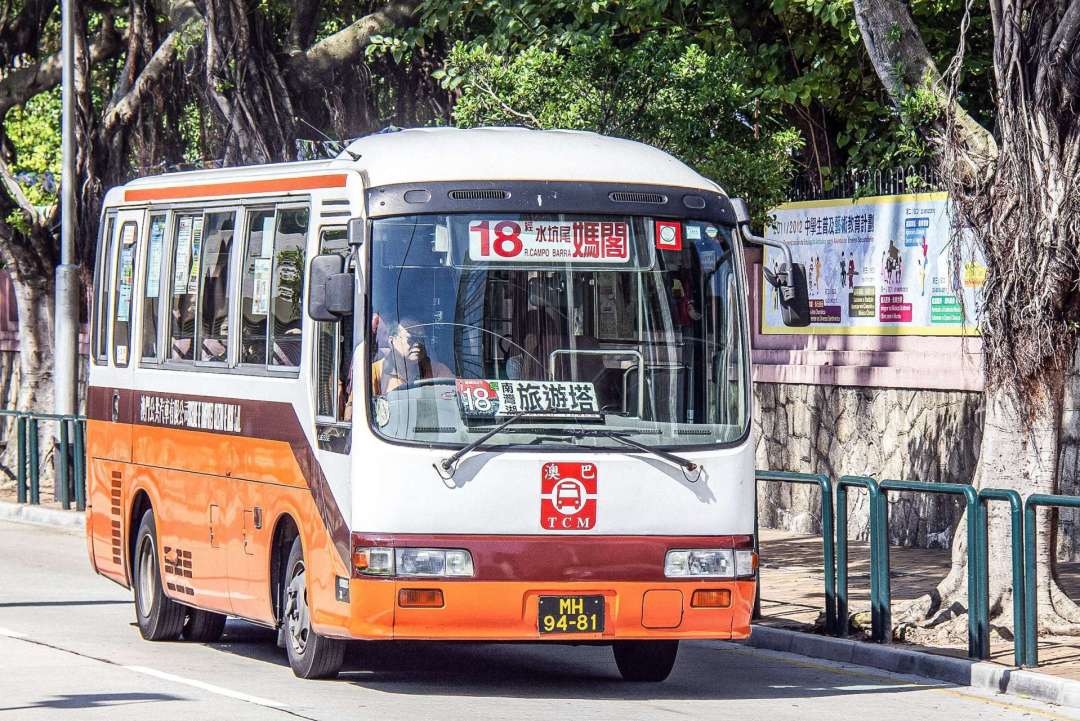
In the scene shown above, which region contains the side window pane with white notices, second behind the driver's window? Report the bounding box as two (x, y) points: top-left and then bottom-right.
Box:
(240, 209), (273, 366)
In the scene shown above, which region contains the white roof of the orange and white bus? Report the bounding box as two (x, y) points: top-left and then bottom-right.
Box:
(106, 127), (719, 205)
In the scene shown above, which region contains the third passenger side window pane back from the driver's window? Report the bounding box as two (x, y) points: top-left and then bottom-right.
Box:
(195, 210), (237, 363)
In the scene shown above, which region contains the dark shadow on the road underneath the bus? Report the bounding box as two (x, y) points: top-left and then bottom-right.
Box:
(204, 618), (946, 700)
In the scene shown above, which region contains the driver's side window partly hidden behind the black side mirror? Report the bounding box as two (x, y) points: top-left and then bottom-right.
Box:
(315, 227), (349, 453)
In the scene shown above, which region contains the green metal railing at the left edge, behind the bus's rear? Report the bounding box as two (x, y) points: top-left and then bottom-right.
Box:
(0, 410), (86, 511)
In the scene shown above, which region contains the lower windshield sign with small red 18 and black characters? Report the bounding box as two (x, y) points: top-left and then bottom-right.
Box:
(457, 379), (599, 418)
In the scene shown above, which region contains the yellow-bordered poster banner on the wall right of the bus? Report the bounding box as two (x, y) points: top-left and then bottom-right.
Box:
(761, 193), (986, 336)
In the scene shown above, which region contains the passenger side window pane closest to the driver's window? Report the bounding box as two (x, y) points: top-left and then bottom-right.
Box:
(270, 208), (308, 368)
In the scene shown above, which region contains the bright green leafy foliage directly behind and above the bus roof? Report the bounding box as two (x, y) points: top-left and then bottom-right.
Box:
(437, 32), (801, 214)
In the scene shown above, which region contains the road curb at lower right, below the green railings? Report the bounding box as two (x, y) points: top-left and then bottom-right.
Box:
(746, 626), (1080, 708)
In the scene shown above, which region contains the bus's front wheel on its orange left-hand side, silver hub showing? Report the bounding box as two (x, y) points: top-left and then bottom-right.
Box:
(281, 536), (346, 679)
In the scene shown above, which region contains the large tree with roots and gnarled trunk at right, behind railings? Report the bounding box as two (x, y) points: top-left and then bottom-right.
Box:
(854, 0), (1080, 634)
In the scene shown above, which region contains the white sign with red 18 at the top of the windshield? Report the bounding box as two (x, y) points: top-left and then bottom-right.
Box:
(469, 219), (630, 263)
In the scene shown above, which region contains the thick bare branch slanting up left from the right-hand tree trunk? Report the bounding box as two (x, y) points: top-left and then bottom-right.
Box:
(854, 0), (997, 160)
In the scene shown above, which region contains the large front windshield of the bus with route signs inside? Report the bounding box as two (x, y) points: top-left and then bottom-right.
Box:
(367, 214), (748, 450)
